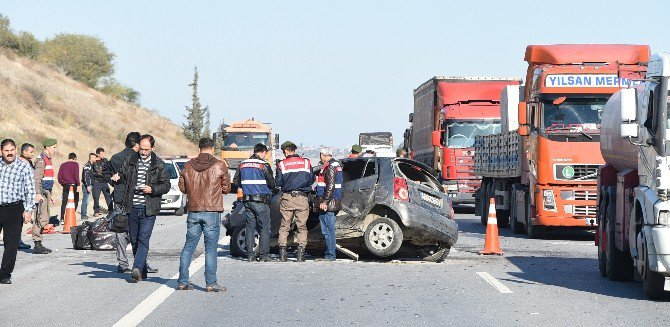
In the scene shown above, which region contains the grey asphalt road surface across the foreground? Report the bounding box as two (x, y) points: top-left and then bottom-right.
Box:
(0, 199), (668, 326)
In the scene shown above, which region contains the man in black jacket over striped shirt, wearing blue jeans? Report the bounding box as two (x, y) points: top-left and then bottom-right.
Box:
(114, 134), (170, 283)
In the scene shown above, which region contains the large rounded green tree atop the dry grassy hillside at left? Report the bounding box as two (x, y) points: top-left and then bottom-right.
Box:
(39, 33), (114, 88)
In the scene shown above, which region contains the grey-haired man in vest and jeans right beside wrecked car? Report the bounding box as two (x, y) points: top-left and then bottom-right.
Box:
(316, 147), (343, 261)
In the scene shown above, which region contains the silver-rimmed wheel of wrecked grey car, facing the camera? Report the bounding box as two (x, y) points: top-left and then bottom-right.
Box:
(363, 217), (403, 258)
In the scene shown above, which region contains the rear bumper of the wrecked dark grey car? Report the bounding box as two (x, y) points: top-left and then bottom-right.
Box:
(393, 201), (458, 246)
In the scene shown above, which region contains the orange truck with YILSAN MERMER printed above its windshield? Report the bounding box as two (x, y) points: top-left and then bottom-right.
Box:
(475, 44), (649, 238)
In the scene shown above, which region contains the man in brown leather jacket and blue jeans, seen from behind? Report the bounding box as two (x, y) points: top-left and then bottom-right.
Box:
(177, 138), (230, 292)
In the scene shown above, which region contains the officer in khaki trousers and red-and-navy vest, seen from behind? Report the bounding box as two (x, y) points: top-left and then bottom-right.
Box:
(277, 141), (314, 262)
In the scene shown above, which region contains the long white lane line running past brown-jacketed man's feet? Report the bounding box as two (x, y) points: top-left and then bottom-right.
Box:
(114, 236), (228, 327)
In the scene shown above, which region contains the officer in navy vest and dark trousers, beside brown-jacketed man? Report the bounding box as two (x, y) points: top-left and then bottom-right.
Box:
(233, 143), (275, 262)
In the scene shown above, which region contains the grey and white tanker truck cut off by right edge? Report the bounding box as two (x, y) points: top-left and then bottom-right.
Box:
(596, 52), (670, 299)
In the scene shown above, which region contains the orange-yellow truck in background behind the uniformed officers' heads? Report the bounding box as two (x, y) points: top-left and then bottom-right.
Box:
(221, 118), (279, 170)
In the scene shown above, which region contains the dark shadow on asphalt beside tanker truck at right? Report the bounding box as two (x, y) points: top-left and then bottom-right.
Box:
(502, 257), (645, 300)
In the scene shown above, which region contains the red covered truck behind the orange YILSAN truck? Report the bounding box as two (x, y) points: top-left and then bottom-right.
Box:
(405, 76), (521, 204)
